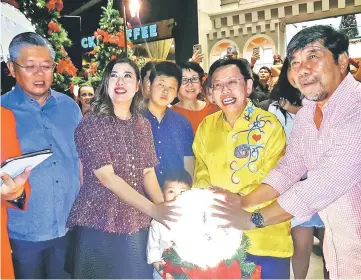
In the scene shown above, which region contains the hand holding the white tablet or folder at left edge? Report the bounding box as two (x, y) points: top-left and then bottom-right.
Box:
(0, 166), (31, 200)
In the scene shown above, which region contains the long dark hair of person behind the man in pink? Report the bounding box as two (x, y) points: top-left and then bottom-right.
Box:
(270, 58), (302, 120)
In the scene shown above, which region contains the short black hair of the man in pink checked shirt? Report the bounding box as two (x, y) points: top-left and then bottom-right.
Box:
(287, 25), (349, 64)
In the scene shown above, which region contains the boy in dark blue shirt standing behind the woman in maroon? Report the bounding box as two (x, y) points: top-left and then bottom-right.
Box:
(145, 61), (194, 186)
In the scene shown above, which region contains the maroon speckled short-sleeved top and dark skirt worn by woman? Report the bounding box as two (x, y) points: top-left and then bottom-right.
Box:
(67, 113), (157, 278)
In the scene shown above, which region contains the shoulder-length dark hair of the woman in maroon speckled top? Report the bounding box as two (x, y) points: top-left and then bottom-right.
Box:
(91, 57), (145, 117)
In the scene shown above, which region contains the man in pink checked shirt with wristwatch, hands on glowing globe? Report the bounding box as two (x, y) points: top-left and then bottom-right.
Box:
(214, 25), (361, 279)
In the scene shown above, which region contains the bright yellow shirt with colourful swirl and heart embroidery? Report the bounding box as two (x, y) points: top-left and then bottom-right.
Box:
(193, 100), (293, 258)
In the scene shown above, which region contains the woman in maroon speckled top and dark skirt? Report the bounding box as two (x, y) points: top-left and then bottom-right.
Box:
(67, 58), (175, 279)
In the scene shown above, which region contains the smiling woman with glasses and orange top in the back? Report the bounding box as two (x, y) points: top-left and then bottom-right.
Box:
(172, 61), (219, 133)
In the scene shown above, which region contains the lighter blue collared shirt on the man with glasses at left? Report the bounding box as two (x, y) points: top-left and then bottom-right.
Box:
(1, 85), (82, 241)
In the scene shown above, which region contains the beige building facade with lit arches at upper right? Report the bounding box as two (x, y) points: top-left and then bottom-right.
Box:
(198, 0), (361, 68)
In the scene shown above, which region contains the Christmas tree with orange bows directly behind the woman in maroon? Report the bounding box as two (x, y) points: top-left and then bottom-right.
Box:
(83, 0), (146, 88)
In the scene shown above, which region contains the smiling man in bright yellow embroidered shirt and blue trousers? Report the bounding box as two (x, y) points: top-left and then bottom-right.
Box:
(193, 59), (293, 279)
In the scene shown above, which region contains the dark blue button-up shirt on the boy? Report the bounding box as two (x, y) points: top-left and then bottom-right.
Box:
(145, 108), (194, 187)
